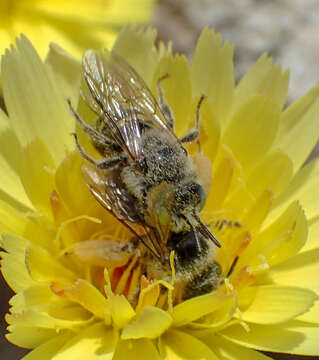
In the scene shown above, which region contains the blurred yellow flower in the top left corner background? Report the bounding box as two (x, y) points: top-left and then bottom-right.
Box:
(0, 0), (154, 57)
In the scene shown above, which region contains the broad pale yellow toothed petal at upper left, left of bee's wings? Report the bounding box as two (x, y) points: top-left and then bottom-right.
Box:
(1, 36), (74, 163)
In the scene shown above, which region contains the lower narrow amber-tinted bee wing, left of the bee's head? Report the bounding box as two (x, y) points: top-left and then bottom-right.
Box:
(82, 164), (164, 259)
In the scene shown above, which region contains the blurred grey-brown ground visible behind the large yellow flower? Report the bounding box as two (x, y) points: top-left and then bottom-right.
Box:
(0, 0), (319, 360)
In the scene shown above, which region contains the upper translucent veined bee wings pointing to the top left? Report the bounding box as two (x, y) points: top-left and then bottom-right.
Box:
(83, 50), (177, 161)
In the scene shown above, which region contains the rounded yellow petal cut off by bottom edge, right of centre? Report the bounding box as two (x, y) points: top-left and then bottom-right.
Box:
(160, 330), (218, 360)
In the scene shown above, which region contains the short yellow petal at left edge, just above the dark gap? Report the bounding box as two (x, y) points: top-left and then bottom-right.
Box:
(0, 234), (35, 292)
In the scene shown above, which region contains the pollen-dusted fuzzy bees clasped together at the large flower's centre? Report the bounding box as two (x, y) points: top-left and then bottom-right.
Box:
(69, 50), (221, 300)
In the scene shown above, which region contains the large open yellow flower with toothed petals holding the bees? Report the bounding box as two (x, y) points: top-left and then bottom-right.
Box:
(0, 27), (319, 360)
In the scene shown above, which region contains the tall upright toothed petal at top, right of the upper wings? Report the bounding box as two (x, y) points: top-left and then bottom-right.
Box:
(192, 28), (234, 124)
